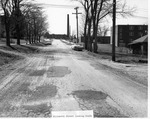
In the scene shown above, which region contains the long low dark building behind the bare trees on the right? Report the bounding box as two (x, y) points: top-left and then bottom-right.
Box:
(81, 36), (110, 44)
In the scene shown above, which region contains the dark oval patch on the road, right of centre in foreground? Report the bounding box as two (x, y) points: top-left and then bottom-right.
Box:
(72, 90), (108, 100)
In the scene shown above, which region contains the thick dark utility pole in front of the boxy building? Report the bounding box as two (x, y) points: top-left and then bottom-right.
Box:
(112, 0), (116, 61)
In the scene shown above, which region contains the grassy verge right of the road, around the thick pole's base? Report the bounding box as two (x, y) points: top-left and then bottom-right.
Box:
(78, 44), (148, 64)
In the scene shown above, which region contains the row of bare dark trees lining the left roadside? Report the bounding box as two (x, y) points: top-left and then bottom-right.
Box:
(0, 0), (48, 46)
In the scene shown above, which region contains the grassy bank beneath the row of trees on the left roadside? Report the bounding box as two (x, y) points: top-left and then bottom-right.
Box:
(0, 39), (54, 67)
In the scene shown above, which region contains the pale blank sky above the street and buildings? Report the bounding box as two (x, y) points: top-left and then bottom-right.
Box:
(36, 0), (148, 34)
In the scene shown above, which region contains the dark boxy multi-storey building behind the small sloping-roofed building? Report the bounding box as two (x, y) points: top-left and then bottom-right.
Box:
(110, 25), (148, 47)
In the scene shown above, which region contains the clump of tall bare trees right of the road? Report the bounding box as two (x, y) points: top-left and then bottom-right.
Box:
(75, 0), (135, 52)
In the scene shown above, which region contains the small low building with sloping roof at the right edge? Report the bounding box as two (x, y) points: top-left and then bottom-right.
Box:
(128, 35), (148, 55)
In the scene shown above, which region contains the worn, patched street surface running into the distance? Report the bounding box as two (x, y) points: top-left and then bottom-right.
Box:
(0, 40), (148, 117)
